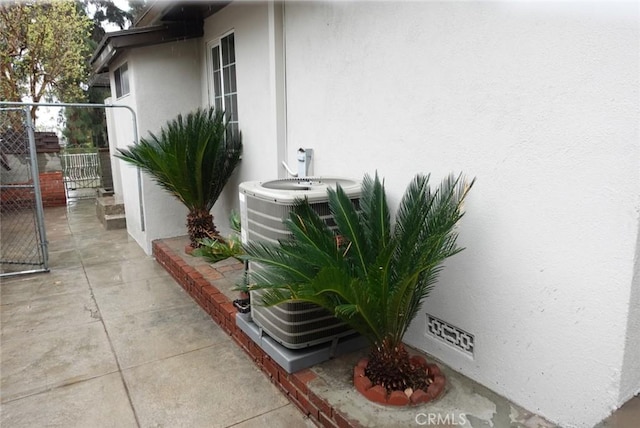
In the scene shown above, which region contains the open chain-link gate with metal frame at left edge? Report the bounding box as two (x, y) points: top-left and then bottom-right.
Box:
(0, 107), (49, 277)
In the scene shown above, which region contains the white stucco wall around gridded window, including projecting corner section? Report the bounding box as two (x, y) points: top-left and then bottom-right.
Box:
(110, 3), (285, 249)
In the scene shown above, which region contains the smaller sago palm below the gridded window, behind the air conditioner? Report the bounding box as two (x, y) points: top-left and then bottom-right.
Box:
(116, 108), (242, 248)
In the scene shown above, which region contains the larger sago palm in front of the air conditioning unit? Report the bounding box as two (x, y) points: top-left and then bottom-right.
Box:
(245, 174), (473, 389)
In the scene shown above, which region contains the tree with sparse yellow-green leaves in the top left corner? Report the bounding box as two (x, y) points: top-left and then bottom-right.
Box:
(0, 1), (92, 122)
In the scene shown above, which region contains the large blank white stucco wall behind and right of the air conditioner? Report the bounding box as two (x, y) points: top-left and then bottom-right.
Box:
(284, 2), (640, 427)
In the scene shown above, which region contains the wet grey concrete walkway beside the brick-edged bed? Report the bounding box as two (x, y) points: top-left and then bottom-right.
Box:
(0, 200), (314, 428)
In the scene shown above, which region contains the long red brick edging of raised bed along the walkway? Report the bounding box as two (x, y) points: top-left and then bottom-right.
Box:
(153, 240), (359, 428)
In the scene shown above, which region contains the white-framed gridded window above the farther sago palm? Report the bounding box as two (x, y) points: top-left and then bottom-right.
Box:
(207, 30), (238, 135)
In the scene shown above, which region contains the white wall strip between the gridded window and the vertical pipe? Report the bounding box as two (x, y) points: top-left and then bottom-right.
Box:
(201, 2), (284, 234)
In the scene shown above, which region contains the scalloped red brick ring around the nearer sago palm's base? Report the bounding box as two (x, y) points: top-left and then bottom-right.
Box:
(353, 355), (446, 406)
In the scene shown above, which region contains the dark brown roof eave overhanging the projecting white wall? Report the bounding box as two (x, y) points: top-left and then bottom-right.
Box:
(90, 1), (231, 78)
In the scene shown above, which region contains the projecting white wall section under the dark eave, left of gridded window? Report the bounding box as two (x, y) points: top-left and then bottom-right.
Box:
(110, 40), (202, 254)
